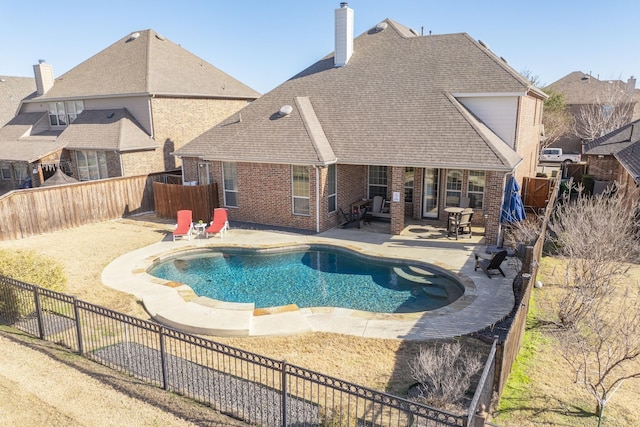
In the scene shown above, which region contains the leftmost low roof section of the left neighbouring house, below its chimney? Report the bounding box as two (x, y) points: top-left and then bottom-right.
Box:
(0, 113), (64, 163)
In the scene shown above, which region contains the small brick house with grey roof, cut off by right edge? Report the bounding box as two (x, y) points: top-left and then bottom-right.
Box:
(583, 120), (640, 206)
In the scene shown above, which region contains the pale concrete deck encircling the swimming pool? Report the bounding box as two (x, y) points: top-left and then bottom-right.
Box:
(102, 223), (518, 340)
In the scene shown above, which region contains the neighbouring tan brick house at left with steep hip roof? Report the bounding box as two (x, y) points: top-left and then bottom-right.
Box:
(0, 30), (259, 189)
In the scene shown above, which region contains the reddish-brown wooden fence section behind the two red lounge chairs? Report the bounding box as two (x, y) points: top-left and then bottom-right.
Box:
(153, 182), (220, 222)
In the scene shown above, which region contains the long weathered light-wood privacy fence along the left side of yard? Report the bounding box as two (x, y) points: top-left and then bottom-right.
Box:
(0, 174), (163, 240)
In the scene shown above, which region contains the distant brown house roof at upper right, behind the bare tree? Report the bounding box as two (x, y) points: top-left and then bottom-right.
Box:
(545, 71), (635, 105)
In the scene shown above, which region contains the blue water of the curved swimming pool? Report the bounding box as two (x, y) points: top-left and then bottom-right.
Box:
(148, 248), (463, 313)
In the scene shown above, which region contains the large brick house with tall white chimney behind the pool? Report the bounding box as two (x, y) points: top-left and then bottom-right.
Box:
(175, 4), (546, 246)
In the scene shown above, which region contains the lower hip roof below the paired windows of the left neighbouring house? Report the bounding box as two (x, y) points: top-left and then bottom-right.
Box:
(58, 108), (159, 152)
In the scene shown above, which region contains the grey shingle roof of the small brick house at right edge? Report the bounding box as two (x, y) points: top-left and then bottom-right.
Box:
(584, 120), (640, 182)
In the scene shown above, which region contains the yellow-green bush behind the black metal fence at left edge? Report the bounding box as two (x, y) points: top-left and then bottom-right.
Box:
(0, 249), (67, 292)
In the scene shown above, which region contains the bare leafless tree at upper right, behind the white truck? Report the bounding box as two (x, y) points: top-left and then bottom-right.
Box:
(573, 83), (635, 141)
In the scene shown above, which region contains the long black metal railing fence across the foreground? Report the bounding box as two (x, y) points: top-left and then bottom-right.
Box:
(0, 276), (482, 427)
